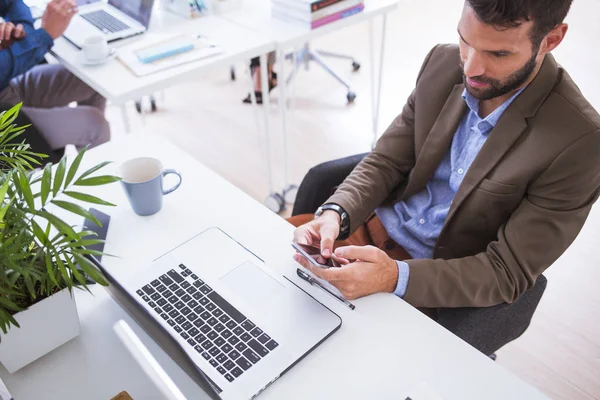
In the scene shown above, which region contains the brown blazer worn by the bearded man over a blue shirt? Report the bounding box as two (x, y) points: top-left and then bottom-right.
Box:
(327, 45), (600, 307)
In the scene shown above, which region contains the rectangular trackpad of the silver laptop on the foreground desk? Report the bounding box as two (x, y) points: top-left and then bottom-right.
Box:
(219, 261), (284, 306)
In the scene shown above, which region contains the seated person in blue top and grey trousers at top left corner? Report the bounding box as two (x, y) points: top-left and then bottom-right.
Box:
(0, 0), (110, 150)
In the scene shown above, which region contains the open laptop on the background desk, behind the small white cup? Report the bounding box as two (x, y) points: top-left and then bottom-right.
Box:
(63, 0), (154, 48)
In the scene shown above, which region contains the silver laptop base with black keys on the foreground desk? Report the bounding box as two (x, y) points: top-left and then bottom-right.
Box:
(119, 228), (342, 399)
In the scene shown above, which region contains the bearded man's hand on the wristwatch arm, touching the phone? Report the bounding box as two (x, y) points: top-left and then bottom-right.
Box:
(294, 210), (341, 258)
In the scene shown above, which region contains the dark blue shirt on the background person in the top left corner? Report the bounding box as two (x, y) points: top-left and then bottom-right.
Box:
(0, 0), (54, 91)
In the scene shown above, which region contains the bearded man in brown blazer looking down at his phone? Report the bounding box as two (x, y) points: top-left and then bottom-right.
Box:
(290, 0), (600, 308)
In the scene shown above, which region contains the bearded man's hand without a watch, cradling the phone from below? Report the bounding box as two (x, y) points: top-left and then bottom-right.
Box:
(294, 246), (398, 300)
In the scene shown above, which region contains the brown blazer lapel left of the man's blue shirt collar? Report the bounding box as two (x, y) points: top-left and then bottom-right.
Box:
(404, 83), (467, 193)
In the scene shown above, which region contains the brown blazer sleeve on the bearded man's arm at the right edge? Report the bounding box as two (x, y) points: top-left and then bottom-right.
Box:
(404, 130), (600, 307)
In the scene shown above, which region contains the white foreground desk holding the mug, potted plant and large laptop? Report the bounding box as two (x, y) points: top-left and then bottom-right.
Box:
(0, 133), (545, 400)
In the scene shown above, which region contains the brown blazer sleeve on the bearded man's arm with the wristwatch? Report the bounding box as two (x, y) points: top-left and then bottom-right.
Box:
(325, 47), (437, 232)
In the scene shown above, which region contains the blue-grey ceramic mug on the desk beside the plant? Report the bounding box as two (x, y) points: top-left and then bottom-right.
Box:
(117, 157), (181, 216)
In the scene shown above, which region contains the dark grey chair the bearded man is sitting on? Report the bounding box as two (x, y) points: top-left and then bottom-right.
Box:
(292, 153), (547, 359)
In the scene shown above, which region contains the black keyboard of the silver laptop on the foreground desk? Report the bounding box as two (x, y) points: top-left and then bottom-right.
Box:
(136, 264), (279, 382)
